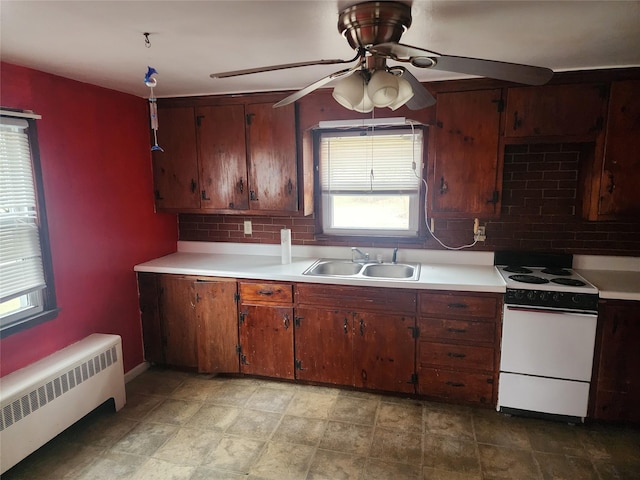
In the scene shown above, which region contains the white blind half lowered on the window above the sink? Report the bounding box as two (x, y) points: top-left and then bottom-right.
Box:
(320, 130), (422, 193)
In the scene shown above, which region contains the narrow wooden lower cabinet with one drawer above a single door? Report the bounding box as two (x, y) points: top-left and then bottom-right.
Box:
(238, 281), (294, 379)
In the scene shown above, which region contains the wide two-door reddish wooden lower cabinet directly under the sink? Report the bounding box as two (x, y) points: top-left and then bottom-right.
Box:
(295, 284), (416, 393)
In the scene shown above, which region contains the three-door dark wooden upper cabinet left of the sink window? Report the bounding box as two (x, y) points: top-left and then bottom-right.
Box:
(153, 96), (311, 215)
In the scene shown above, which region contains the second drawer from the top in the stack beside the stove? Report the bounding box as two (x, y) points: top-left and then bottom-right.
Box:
(418, 318), (496, 344)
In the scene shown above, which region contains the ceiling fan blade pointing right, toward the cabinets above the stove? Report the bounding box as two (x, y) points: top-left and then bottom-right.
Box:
(369, 43), (553, 85)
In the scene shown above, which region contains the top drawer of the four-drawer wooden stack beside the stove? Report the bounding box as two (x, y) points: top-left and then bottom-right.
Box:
(419, 293), (500, 320)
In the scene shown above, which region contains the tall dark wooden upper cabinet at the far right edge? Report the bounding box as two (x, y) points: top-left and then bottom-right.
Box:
(583, 80), (640, 220)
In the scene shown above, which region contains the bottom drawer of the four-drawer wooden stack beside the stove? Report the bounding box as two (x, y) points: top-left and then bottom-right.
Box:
(418, 368), (493, 405)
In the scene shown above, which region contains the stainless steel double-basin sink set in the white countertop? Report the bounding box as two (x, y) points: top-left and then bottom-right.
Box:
(302, 258), (420, 281)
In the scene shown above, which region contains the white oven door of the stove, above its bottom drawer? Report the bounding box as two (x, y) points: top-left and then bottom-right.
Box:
(500, 305), (598, 382)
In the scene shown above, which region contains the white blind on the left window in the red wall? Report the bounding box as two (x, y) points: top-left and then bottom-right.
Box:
(0, 117), (45, 302)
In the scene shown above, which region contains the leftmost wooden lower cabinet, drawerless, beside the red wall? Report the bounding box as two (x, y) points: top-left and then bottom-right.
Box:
(138, 273), (239, 373)
